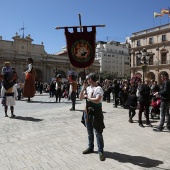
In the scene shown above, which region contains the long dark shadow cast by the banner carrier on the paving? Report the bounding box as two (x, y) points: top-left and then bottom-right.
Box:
(105, 151), (164, 170)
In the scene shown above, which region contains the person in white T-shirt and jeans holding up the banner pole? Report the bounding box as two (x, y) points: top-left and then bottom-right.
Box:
(79, 73), (105, 161)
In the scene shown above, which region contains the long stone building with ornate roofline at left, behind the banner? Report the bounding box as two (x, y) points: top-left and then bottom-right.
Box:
(0, 33), (100, 82)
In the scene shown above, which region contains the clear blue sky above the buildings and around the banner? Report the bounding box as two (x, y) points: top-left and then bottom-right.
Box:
(0, 0), (170, 54)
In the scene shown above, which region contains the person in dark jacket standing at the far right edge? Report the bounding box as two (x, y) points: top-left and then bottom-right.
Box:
(153, 72), (170, 132)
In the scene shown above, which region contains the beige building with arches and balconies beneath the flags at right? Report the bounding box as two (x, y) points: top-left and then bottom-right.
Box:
(129, 24), (170, 84)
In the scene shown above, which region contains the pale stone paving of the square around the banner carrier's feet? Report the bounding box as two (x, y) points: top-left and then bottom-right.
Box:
(0, 97), (170, 170)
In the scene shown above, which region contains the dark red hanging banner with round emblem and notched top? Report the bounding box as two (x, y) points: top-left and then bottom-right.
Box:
(65, 26), (96, 68)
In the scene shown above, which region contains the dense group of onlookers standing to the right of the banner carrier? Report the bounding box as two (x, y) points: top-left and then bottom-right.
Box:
(101, 72), (170, 131)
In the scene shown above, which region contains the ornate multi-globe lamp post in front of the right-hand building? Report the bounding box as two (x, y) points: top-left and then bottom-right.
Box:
(136, 48), (151, 82)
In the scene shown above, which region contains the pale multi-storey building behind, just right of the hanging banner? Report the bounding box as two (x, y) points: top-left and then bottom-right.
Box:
(96, 41), (130, 78)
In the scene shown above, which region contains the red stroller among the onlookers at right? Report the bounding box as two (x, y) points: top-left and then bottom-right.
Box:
(149, 96), (161, 119)
